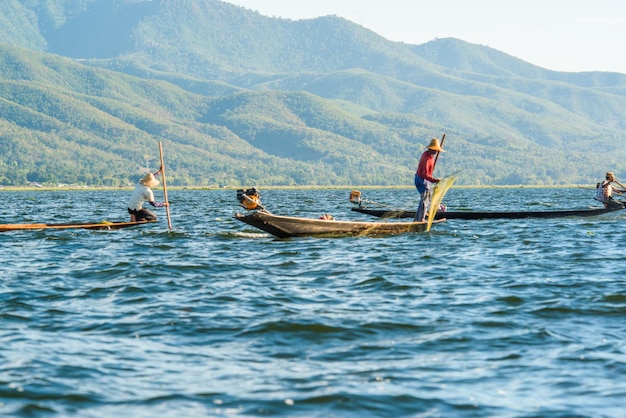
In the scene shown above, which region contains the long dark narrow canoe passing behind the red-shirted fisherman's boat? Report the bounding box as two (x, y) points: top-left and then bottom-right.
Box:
(352, 207), (624, 220)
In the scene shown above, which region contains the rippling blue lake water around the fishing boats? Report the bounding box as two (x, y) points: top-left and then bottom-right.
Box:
(0, 188), (626, 417)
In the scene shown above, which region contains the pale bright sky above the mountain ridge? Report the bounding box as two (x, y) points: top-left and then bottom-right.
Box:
(225, 0), (626, 74)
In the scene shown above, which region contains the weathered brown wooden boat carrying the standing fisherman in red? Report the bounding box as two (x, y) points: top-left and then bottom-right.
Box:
(235, 210), (442, 238)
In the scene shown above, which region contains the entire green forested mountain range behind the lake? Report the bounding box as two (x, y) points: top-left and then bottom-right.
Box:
(0, 0), (626, 185)
